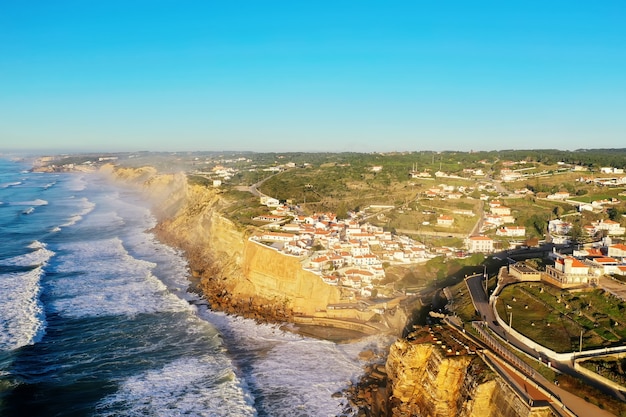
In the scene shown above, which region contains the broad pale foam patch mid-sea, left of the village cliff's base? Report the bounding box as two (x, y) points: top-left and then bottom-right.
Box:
(48, 238), (191, 317)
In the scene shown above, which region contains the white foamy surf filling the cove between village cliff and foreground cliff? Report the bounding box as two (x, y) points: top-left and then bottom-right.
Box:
(201, 311), (389, 417)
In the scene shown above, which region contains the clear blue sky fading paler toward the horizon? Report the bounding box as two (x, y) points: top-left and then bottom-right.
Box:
(0, 0), (626, 152)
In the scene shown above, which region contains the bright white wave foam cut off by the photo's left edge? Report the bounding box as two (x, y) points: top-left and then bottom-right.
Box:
(0, 267), (45, 350)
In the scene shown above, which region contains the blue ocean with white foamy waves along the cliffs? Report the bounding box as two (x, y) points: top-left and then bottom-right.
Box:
(0, 159), (389, 417)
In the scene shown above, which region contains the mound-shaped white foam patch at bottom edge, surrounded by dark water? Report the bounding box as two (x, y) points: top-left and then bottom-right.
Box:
(96, 355), (256, 417)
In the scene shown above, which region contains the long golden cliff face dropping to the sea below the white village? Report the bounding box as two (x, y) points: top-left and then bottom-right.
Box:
(104, 167), (340, 321)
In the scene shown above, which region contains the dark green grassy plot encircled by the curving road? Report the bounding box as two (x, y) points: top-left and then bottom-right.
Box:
(497, 283), (626, 352)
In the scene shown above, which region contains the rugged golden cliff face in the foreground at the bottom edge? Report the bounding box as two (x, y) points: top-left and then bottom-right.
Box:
(378, 339), (552, 417)
